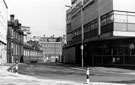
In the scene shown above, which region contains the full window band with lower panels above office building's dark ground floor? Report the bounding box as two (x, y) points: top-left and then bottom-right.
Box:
(67, 11), (135, 42)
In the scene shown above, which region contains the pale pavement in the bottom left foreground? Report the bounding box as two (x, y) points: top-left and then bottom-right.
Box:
(0, 66), (83, 85)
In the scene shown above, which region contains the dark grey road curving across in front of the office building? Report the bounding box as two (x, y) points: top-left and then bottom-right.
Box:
(20, 64), (135, 84)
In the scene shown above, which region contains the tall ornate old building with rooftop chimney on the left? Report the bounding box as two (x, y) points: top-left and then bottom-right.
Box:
(7, 15), (24, 63)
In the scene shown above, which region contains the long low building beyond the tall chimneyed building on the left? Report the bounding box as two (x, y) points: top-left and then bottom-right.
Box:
(22, 40), (43, 63)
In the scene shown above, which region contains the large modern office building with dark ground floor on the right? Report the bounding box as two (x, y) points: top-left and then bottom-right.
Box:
(63, 0), (135, 66)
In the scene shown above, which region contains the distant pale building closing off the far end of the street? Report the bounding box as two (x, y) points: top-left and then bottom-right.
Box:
(34, 35), (64, 61)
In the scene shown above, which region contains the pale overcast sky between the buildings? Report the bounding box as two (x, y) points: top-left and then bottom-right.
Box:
(5, 0), (71, 37)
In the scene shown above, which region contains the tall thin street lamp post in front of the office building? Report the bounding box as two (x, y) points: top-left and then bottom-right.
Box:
(65, 0), (84, 67)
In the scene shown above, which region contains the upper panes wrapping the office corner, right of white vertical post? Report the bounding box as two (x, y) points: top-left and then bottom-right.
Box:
(101, 11), (135, 26)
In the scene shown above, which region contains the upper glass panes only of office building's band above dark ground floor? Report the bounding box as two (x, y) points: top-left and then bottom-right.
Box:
(72, 11), (135, 40)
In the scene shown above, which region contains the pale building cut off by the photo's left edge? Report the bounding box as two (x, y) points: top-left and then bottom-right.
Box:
(0, 0), (8, 64)
